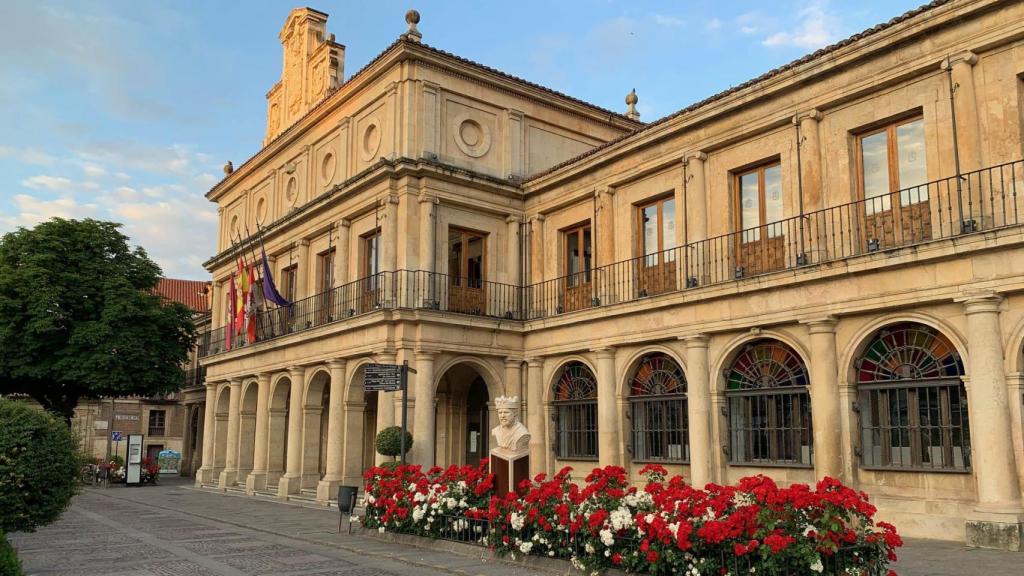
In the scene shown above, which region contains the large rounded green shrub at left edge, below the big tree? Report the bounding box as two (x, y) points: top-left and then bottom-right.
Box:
(0, 398), (83, 532)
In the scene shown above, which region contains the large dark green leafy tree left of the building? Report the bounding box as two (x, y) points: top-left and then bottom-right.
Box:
(0, 218), (196, 419)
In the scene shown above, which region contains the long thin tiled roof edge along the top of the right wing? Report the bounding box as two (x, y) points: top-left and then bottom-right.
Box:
(524, 0), (953, 181)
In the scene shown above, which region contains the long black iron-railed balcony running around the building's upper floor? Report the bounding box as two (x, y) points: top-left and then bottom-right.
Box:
(200, 160), (1024, 357)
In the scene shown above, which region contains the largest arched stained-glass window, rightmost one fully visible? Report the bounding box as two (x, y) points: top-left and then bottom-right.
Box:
(855, 322), (971, 471)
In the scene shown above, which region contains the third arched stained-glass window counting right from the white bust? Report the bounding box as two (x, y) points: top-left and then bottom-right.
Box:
(725, 339), (814, 466)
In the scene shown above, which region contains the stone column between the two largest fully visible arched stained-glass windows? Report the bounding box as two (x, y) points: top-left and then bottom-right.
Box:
(805, 317), (843, 480)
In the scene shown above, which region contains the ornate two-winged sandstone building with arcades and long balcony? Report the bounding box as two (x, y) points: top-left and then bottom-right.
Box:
(198, 0), (1024, 547)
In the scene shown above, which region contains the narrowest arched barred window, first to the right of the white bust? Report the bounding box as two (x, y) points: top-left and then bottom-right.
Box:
(552, 362), (597, 460)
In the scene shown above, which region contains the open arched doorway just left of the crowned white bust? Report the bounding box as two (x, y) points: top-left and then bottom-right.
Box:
(432, 362), (498, 465)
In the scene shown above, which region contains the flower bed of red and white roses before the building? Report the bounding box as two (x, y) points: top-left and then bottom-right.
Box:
(362, 462), (902, 576)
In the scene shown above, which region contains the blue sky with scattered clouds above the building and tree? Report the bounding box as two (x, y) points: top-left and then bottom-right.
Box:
(0, 0), (923, 279)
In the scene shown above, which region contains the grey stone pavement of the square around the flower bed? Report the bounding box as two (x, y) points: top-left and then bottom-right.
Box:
(10, 481), (1024, 576)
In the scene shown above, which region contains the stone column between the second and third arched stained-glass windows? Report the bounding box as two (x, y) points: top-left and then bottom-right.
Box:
(683, 334), (715, 488)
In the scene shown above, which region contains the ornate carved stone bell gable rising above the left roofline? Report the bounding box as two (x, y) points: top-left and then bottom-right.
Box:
(263, 8), (345, 146)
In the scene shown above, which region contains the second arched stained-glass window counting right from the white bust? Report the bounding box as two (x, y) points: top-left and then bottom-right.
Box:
(630, 353), (690, 462)
